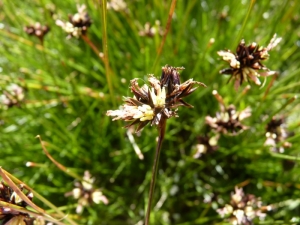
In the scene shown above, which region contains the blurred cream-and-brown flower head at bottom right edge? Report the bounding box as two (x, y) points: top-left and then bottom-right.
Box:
(217, 187), (266, 225)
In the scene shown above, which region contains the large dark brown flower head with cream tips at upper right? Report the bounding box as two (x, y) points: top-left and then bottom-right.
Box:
(218, 34), (281, 89)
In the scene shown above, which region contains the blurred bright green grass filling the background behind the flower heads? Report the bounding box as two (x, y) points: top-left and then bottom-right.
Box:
(0, 0), (300, 225)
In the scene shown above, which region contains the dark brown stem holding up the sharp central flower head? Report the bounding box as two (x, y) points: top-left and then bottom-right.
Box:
(145, 116), (167, 225)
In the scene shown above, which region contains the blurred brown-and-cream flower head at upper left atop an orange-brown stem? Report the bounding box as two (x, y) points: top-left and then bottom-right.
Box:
(56, 5), (92, 38)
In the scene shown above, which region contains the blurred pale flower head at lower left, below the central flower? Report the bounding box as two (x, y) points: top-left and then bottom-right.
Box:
(65, 171), (108, 214)
